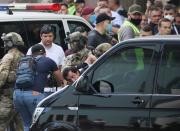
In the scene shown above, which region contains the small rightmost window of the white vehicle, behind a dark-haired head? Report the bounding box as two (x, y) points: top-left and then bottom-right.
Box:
(67, 21), (91, 33)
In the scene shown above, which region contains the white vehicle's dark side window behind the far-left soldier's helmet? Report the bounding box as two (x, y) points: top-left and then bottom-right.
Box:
(0, 21), (28, 58)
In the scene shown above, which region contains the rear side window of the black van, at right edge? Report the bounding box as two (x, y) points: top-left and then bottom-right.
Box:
(157, 44), (180, 94)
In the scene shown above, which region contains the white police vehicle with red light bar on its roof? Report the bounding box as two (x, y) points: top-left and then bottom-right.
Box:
(0, 3), (93, 58)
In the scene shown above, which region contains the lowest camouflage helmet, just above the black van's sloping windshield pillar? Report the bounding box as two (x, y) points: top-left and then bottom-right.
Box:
(94, 43), (112, 57)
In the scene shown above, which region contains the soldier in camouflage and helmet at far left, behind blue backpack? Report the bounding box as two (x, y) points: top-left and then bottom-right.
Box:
(0, 32), (24, 131)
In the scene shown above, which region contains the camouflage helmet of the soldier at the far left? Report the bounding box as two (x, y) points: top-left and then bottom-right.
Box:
(1, 32), (24, 47)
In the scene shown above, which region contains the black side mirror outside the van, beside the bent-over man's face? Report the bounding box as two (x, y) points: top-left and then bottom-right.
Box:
(75, 76), (89, 93)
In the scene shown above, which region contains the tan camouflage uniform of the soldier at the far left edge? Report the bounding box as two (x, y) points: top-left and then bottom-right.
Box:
(0, 34), (24, 131)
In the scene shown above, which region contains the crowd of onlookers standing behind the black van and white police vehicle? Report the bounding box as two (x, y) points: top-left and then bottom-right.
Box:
(57, 0), (180, 47)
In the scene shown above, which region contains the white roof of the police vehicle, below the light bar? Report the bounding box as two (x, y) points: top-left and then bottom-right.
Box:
(0, 11), (83, 21)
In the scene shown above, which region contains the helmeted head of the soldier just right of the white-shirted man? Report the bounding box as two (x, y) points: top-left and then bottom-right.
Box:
(69, 32), (87, 53)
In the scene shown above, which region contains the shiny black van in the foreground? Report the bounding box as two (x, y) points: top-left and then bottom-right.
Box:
(31, 36), (180, 131)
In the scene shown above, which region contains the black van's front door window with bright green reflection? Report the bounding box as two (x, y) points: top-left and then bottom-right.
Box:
(92, 46), (155, 93)
